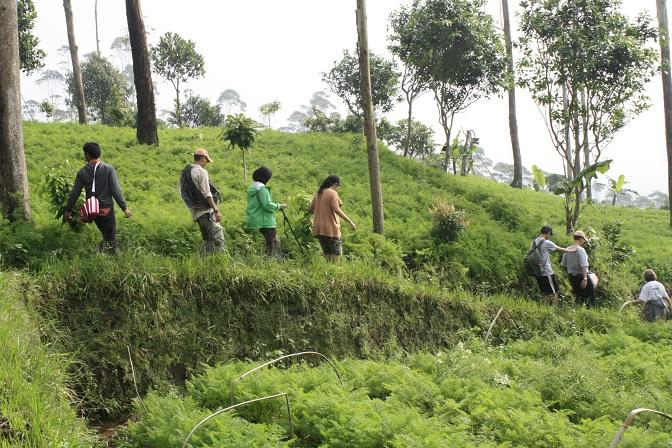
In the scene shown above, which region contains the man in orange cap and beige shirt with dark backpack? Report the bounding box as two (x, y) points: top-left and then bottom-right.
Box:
(180, 148), (226, 255)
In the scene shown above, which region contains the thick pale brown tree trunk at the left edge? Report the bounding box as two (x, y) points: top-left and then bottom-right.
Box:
(0, 0), (30, 220)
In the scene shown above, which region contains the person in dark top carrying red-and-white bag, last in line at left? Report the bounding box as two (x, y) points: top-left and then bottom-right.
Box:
(63, 142), (133, 252)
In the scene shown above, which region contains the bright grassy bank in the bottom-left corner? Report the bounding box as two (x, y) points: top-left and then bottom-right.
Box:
(0, 274), (102, 448)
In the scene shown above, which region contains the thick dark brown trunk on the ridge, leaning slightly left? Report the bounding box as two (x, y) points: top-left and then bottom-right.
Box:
(126, 0), (159, 146)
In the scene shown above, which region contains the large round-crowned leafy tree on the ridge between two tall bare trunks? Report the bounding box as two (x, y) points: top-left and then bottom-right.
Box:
(390, 0), (506, 174)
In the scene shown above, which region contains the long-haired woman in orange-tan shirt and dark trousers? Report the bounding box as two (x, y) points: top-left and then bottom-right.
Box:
(310, 174), (357, 262)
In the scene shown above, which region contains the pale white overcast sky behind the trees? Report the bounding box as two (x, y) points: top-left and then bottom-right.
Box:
(22, 0), (667, 194)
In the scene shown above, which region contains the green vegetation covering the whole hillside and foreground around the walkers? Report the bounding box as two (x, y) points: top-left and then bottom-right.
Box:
(0, 123), (672, 447)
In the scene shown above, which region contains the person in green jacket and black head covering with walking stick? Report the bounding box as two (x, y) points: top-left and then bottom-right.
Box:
(247, 166), (287, 258)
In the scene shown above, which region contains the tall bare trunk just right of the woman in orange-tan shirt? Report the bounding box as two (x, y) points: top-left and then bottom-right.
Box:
(357, 0), (385, 235)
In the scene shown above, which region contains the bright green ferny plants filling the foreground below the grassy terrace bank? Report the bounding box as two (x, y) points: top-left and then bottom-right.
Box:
(119, 324), (672, 448)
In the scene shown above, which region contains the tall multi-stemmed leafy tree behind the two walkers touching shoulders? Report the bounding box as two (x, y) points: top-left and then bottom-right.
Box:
(519, 0), (657, 231)
